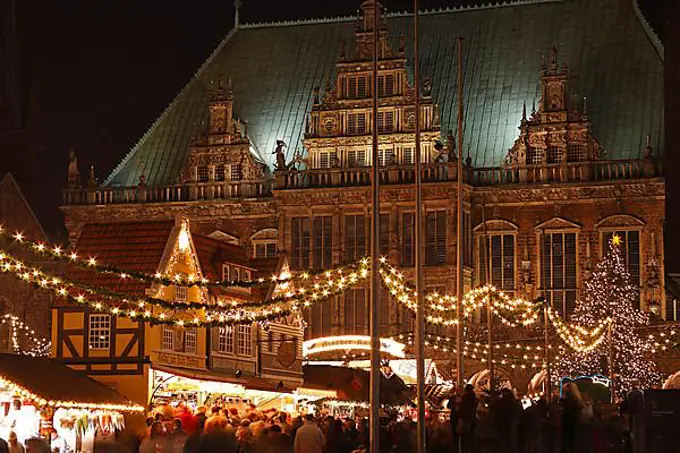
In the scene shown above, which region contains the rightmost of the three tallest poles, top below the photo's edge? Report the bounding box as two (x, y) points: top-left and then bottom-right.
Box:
(456, 37), (464, 389)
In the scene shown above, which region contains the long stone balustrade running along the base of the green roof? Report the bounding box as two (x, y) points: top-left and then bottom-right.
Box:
(63, 159), (663, 205)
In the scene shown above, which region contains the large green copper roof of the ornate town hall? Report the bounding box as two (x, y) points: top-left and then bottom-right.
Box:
(106, 0), (663, 186)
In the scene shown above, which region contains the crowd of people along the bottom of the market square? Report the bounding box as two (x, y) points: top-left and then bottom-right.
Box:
(0, 383), (644, 453)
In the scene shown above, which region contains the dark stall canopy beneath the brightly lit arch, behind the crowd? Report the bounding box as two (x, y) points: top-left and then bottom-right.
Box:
(303, 365), (413, 406)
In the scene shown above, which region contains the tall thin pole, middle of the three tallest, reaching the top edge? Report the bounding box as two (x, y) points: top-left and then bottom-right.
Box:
(413, 0), (427, 453)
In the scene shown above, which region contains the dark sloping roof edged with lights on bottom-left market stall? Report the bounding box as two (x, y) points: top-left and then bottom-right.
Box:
(0, 354), (144, 412)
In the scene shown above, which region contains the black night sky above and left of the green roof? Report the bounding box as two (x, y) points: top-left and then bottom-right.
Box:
(2, 0), (674, 239)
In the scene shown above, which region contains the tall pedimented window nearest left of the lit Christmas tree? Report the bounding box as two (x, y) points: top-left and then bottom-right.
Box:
(541, 232), (576, 318)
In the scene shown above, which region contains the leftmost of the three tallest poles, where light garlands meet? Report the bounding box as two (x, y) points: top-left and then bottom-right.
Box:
(370, 1), (380, 453)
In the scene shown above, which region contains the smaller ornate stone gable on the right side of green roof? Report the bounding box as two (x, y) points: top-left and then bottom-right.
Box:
(505, 48), (604, 166)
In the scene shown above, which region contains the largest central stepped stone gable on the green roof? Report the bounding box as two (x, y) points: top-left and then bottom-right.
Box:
(304, 0), (439, 169)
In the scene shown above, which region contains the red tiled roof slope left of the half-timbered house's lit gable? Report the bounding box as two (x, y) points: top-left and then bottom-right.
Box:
(70, 221), (174, 296)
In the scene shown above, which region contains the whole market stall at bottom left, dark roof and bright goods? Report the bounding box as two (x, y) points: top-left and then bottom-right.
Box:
(0, 354), (144, 453)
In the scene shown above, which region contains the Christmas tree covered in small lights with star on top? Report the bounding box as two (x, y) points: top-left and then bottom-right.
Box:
(554, 235), (660, 396)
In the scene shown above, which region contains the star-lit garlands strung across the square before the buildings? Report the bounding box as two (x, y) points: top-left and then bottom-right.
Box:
(0, 228), (620, 351)
